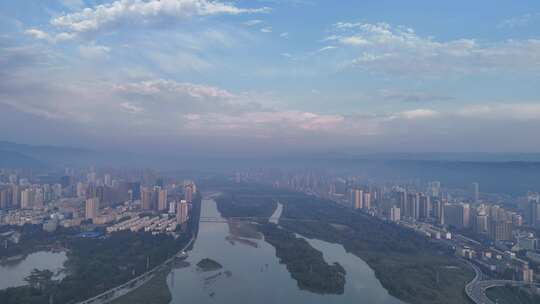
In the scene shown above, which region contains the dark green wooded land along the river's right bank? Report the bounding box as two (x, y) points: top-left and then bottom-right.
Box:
(216, 184), (474, 304)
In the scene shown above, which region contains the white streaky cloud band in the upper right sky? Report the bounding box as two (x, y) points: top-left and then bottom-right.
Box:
(323, 22), (540, 77)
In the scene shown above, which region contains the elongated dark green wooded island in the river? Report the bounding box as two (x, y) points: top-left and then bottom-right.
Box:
(259, 223), (345, 294)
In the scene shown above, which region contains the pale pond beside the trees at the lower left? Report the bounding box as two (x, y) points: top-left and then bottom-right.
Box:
(0, 251), (67, 289)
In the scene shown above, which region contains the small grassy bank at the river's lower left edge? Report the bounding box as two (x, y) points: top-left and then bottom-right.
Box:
(111, 270), (172, 304)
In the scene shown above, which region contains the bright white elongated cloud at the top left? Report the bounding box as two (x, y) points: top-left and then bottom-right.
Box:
(34, 0), (270, 40)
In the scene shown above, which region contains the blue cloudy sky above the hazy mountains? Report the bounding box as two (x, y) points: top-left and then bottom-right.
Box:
(0, 0), (540, 155)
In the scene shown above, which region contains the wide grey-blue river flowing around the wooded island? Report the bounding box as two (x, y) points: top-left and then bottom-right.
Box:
(167, 200), (402, 304)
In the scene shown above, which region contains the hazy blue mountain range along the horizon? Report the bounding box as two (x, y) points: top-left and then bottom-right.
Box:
(0, 141), (540, 195)
